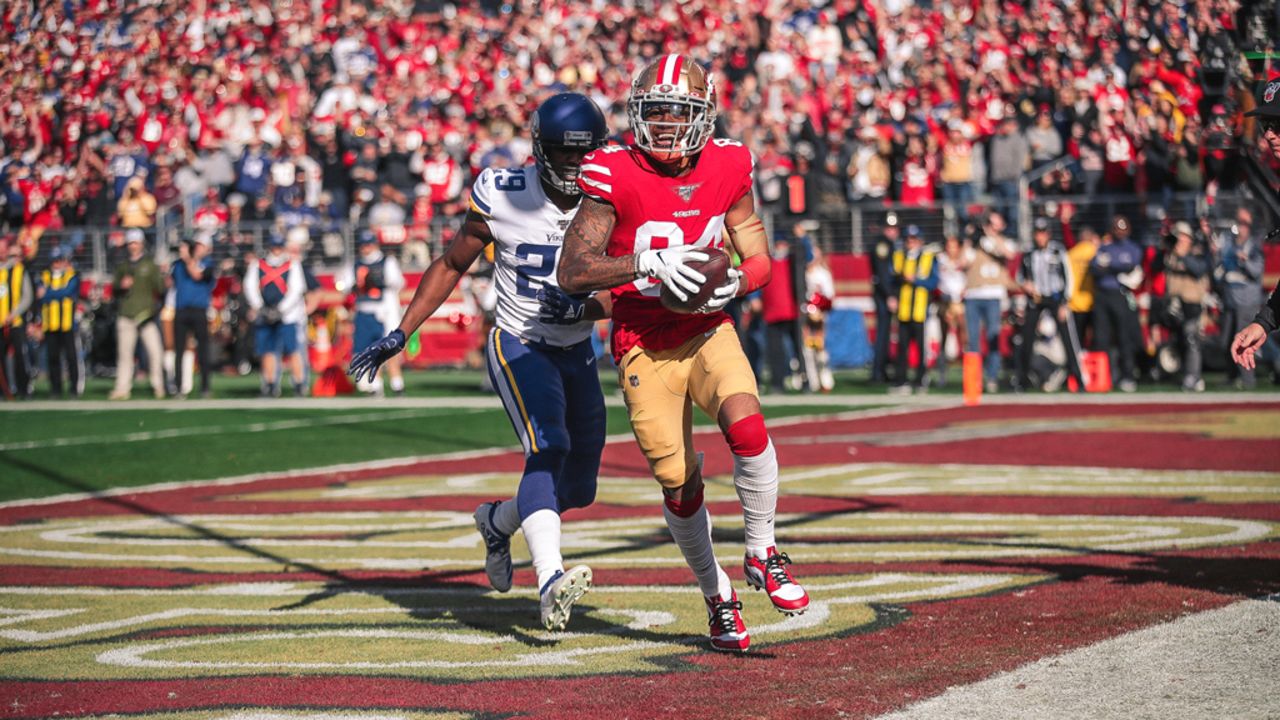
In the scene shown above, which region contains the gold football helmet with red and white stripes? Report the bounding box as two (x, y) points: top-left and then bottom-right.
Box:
(627, 54), (716, 161)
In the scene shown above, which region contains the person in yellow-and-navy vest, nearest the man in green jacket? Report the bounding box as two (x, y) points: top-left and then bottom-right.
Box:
(36, 245), (84, 397)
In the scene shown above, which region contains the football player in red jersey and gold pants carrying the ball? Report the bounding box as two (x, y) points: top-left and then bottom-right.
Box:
(557, 55), (809, 652)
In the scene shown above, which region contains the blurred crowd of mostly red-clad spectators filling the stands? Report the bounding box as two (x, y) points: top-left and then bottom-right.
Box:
(0, 0), (1274, 393)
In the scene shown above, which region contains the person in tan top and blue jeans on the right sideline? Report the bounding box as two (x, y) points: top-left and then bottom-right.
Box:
(964, 211), (1018, 392)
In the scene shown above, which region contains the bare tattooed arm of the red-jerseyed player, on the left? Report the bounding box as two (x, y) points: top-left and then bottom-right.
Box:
(557, 197), (635, 292)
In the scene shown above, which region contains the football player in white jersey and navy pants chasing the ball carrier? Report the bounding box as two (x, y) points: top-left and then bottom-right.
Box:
(349, 92), (612, 630)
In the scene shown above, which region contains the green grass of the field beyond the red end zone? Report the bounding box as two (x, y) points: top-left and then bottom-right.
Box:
(0, 404), (860, 501)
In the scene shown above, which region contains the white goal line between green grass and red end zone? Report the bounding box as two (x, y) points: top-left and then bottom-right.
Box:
(0, 404), (938, 510)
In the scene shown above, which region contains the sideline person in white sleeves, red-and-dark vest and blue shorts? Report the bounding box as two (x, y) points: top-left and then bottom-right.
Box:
(244, 233), (307, 397)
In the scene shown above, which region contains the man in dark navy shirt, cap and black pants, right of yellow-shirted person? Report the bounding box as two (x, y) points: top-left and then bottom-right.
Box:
(1089, 215), (1142, 392)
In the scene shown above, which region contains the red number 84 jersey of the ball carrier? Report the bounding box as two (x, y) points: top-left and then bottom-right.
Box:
(577, 138), (755, 360)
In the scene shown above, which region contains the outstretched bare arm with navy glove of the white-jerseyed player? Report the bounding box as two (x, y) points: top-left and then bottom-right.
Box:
(347, 210), (493, 380)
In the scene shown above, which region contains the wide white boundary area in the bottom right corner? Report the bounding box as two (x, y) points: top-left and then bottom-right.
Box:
(879, 600), (1280, 720)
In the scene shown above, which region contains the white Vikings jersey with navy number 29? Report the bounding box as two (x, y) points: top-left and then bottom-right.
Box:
(471, 165), (591, 347)
